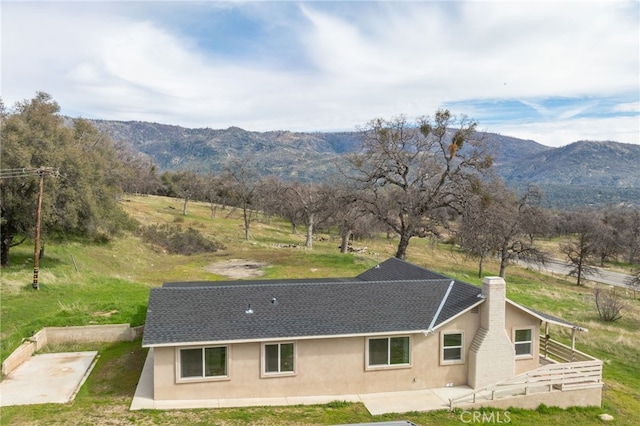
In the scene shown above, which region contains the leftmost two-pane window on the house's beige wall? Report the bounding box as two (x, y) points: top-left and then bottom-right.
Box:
(179, 346), (227, 379)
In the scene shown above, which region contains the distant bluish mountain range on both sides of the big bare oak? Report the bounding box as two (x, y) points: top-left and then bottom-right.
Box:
(90, 120), (640, 208)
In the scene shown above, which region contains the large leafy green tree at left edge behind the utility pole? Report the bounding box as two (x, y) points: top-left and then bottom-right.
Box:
(0, 92), (132, 266)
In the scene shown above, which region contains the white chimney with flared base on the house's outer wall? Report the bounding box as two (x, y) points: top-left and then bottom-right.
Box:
(468, 277), (516, 389)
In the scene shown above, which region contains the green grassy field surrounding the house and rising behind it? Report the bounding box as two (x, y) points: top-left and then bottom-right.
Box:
(0, 197), (640, 425)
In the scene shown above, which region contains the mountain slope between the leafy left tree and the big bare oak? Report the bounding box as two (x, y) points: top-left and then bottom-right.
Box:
(93, 120), (348, 182)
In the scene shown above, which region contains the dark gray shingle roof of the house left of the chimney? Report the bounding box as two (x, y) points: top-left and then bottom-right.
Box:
(143, 259), (480, 346)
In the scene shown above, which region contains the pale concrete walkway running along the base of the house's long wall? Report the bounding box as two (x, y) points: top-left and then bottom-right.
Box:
(130, 349), (471, 415)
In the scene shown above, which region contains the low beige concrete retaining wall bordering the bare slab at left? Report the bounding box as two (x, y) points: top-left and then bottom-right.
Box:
(2, 324), (144, 376)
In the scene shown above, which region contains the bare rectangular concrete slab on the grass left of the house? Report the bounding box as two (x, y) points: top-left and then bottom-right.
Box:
(0, 351), (98, 407)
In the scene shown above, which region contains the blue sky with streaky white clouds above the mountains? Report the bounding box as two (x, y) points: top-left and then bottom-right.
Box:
(0, 0), (640, 146)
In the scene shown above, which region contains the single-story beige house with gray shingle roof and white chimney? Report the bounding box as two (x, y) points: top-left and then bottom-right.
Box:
(142, 258), (602, 407)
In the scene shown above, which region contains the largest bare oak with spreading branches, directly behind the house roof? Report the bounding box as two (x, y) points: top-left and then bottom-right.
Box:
(348, 110), (492, 259)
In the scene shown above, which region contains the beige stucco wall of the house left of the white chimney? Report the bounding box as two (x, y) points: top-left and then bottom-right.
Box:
(154, 313), (477, 400)
